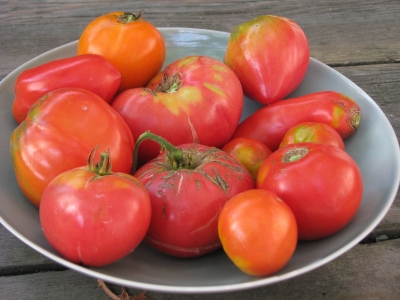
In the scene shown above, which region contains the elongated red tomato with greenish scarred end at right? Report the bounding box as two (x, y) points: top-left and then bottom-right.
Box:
(232, 91), (361, 151)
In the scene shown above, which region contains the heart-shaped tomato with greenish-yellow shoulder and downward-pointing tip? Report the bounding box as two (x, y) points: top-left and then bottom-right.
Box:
(224, 15), (310, 104)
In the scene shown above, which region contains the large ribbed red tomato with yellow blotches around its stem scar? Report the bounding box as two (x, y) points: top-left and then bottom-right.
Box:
(112, 56), (244, 164)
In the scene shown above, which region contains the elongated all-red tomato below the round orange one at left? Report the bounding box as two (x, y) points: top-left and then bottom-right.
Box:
(12, 54), (121, 124)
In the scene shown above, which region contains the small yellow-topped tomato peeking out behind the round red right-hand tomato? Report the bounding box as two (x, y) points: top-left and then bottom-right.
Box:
(279, 122), (344, 150)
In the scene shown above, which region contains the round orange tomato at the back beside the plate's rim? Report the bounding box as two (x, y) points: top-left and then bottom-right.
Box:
(77, 12), (166, 92)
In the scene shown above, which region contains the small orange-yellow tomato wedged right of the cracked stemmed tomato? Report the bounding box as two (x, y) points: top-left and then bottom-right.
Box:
(222, 137), (272, 180)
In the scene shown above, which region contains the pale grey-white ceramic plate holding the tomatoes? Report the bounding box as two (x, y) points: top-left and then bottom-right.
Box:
(0, 28), (400, 293)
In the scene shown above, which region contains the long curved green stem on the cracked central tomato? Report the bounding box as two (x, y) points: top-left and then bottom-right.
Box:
(132, 131), (194, 174)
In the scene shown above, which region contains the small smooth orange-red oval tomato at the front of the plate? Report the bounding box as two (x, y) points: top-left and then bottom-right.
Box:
(218, 189), (297, 276)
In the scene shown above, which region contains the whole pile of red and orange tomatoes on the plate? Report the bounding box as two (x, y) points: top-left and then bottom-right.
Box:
(10, 12), (363, 276)
